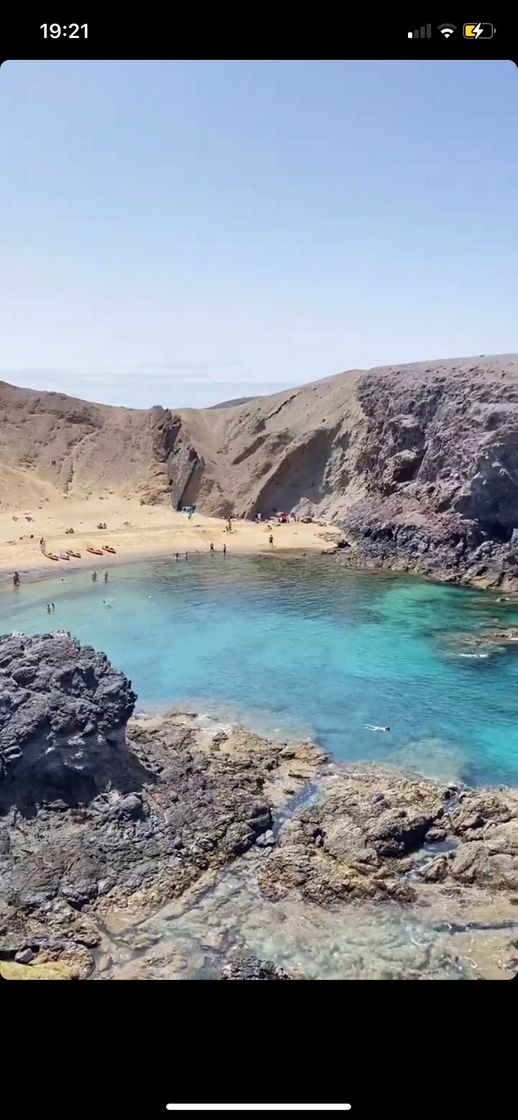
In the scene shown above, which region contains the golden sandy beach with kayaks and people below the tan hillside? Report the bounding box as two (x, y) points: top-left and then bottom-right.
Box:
(0, 495), (340, 586)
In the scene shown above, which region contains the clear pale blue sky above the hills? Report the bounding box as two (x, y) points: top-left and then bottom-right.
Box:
(0, 62), (518, 407)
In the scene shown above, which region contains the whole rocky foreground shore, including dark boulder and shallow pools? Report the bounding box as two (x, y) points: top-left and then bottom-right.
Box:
(0, 634), (518, 979)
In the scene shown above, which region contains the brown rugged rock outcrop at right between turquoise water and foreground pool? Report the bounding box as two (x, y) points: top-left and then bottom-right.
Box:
(259, 767), (518, 905)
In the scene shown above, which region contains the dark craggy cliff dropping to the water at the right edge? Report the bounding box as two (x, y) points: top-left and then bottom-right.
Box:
(337, 357), (518, 587)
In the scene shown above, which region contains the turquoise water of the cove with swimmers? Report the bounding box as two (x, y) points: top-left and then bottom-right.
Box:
(0, 556), (518, 784)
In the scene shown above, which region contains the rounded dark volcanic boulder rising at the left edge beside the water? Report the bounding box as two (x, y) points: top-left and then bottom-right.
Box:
(0, 633), (138, 814)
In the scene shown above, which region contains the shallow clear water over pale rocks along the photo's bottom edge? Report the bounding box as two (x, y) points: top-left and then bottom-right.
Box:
(93, 850), (518, 980)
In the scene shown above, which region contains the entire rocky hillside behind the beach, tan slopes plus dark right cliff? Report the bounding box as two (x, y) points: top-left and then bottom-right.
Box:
(0, 355), (518, 582)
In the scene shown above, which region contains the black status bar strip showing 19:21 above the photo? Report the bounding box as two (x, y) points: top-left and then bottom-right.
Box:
(0, 14), (518, 65)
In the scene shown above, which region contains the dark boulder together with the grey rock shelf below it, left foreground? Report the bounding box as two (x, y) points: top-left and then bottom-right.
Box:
(0, 635), (323, 976)
